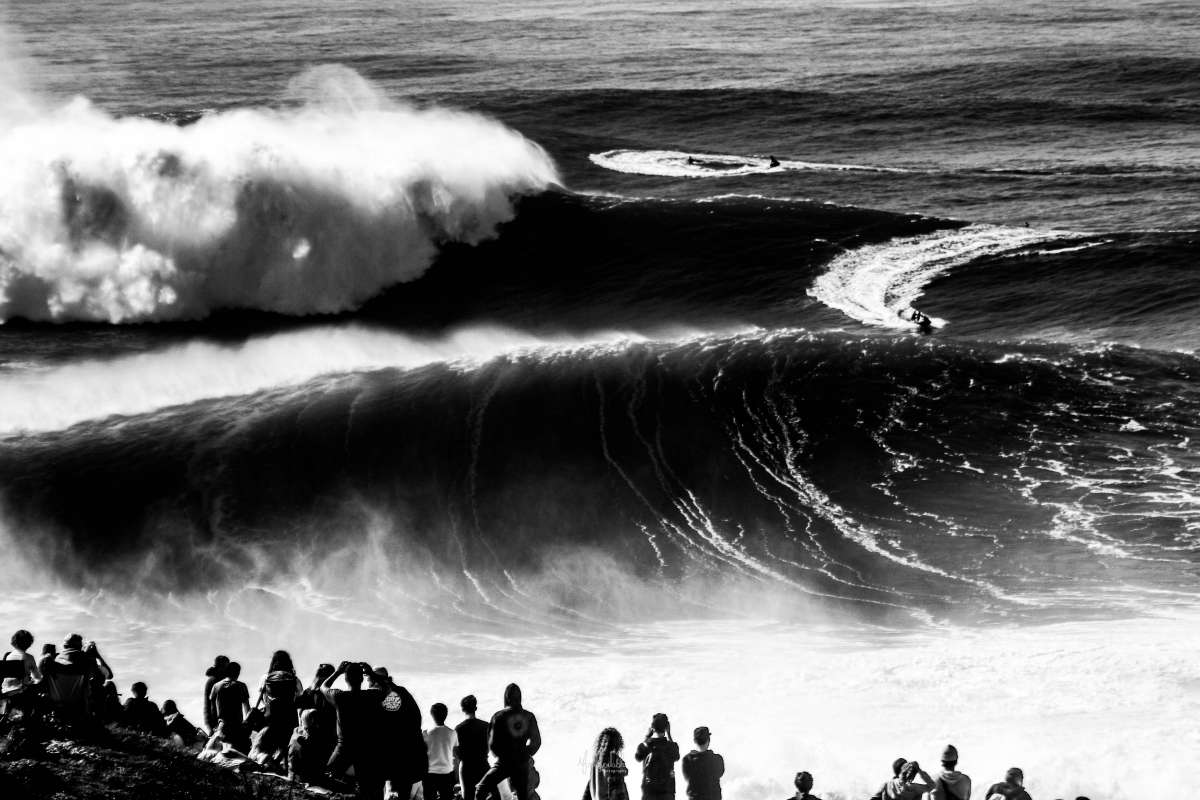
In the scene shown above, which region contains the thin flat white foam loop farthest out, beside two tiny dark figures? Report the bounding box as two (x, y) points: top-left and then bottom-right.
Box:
(588, 150), (907, 178)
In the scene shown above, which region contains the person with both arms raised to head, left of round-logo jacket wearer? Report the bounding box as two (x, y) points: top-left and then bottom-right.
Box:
(323, 661), (386, 800)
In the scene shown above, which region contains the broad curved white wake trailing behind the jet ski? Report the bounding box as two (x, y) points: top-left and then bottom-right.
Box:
(809, 225), (1082, 329)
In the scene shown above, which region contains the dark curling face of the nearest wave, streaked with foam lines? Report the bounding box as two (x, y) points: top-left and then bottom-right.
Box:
(7, 331), (1200, 616)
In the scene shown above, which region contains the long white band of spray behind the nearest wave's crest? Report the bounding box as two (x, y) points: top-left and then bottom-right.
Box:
(0, 325), (753, 435)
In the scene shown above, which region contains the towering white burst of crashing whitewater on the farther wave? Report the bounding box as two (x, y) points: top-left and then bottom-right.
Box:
(0, 67), (558, 323)
